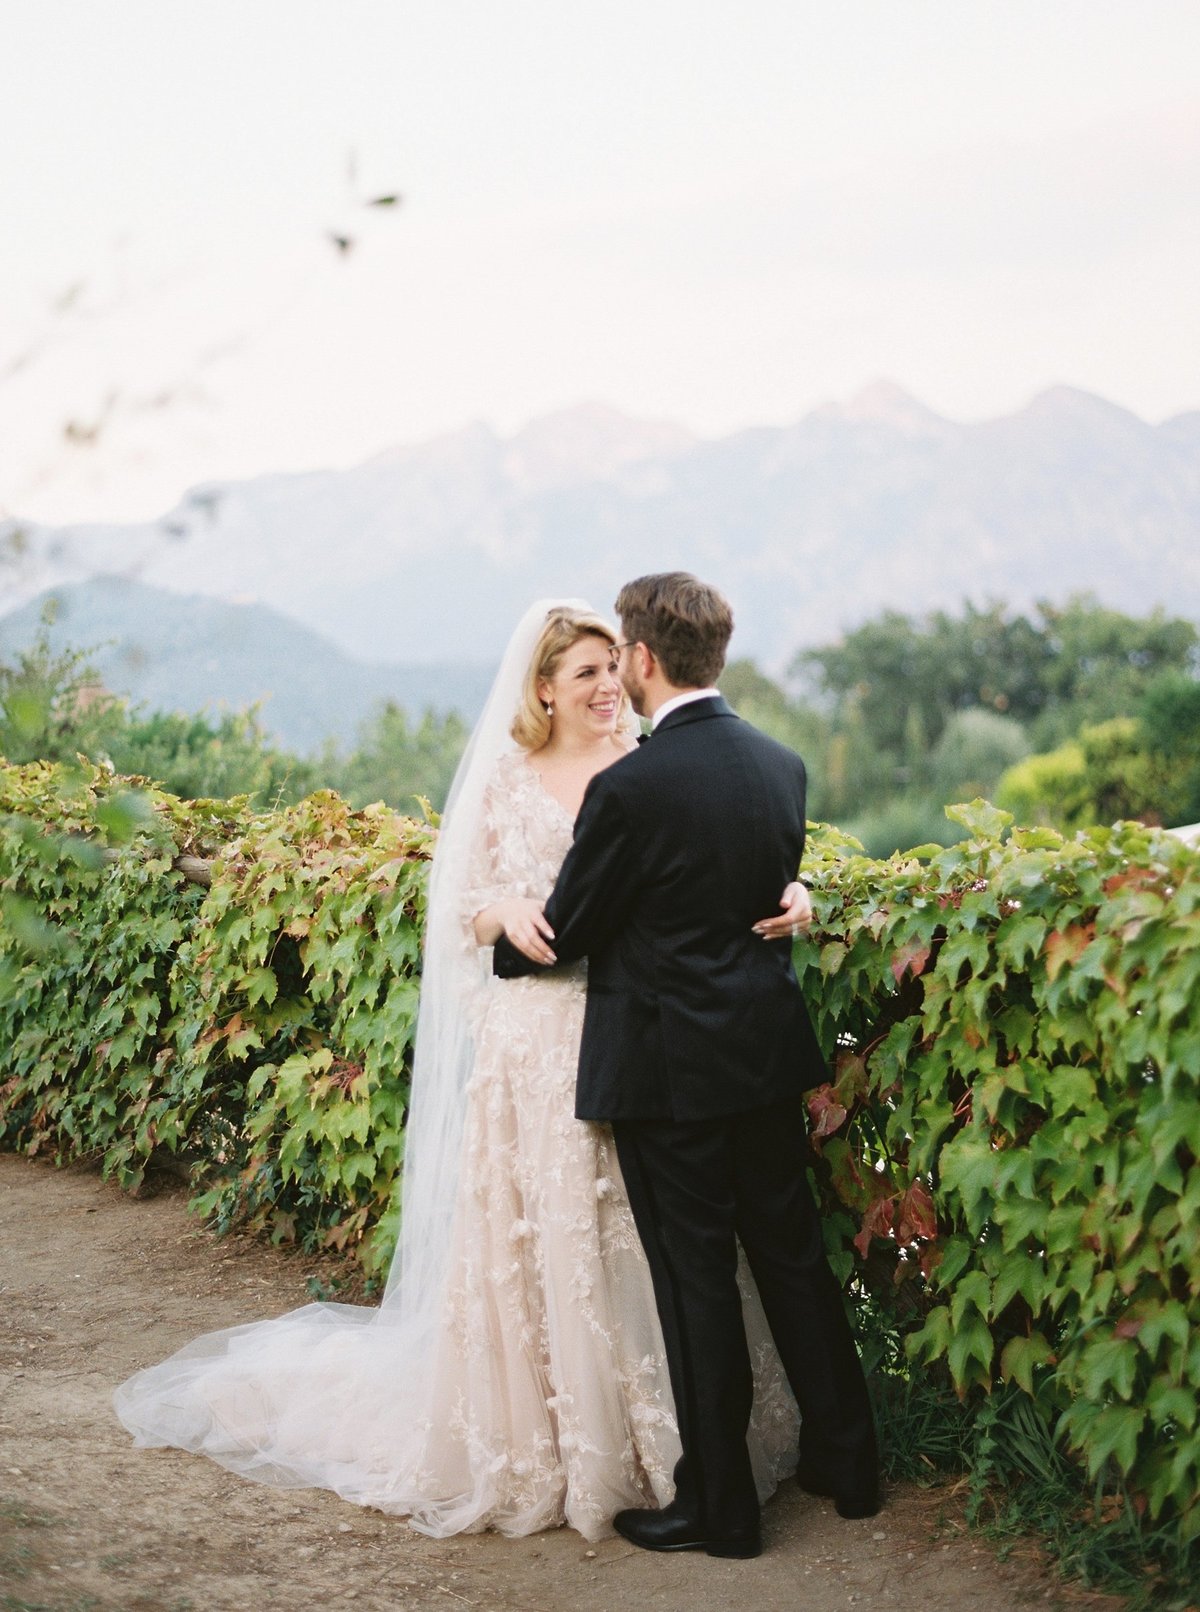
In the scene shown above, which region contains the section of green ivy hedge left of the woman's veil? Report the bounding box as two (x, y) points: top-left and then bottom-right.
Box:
(0, 762), (432, 1270)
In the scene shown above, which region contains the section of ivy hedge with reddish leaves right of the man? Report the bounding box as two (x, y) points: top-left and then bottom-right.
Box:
(797, 801), (1200, 1541)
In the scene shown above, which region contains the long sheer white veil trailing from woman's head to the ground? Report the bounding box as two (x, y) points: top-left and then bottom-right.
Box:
(115, 600), (587, 1510)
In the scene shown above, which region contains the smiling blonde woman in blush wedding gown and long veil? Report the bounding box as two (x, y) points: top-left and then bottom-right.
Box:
(115, 600), (805, 1539)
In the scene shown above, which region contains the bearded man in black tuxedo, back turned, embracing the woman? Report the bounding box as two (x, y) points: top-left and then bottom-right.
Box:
(494, 572), (879, 1557)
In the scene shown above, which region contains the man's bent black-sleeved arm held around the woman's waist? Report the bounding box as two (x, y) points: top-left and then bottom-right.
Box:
(492, 772), (637, 980)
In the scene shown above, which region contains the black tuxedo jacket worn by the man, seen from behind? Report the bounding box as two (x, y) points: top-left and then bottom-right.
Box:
(492, 698), (827, 1120)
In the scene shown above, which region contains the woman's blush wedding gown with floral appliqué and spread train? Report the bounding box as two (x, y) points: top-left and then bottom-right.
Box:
(116, 753), (798, 1539)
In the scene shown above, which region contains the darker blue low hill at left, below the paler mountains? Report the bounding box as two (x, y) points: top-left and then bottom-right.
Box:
(0, 577), (492, 753)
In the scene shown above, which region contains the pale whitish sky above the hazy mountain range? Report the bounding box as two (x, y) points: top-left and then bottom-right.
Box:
(0, 0), (1200, 522)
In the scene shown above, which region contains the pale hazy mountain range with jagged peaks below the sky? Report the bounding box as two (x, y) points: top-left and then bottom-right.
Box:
(0, 384), (1200, 683)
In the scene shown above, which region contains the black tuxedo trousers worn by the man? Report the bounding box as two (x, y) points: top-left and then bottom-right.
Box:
(613, 1096), (877, 1530)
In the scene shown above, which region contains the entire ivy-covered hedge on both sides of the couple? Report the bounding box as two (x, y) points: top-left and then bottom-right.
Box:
(0, 762), (1200, 1546)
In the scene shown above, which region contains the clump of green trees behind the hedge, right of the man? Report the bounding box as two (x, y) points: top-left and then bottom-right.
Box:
(792, 596), (1200, 856)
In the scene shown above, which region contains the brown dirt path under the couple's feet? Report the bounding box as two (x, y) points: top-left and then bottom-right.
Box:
(0, 1154), (1116, 1612)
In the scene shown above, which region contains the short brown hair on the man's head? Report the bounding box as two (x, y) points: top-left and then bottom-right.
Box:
(616, 571), (734, 688)
